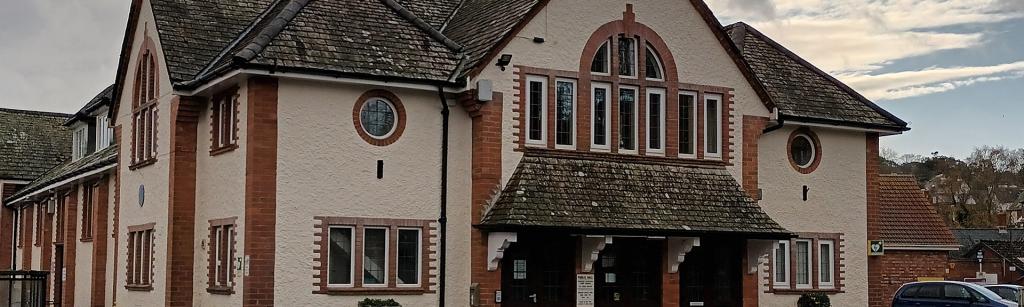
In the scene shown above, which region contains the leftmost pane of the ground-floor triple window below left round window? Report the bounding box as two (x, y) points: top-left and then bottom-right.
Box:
(327, 226), (355, 287)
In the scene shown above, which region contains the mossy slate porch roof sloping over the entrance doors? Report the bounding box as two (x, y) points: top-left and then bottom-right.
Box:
(480, 152), (790, 237)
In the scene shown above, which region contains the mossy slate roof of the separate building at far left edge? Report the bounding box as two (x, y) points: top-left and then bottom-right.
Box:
(0, 108), (71, 180)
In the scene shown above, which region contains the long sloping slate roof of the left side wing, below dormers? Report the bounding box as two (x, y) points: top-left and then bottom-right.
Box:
(4, 145), (118, 204)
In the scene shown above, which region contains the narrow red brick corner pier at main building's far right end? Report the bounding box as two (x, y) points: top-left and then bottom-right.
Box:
(868, 132), (889, 307)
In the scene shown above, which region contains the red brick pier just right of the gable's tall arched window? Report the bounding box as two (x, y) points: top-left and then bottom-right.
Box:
(164, 96), (205, 306)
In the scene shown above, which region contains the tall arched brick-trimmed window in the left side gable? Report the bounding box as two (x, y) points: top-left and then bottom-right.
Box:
(131, 45), (159, 169)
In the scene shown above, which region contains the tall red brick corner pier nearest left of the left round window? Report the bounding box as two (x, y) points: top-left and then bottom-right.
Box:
(242, 77), (278, 307)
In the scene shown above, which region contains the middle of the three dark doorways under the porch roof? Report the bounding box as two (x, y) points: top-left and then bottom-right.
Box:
(594, 237), (665, 307)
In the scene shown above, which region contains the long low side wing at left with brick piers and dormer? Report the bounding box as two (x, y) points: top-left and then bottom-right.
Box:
(4, 87), (118, 306)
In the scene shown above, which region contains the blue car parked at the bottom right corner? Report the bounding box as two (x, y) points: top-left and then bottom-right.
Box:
(893, 281), (1019, 307)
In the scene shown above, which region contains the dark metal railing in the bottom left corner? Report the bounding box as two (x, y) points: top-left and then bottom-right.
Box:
(0, 271), (49, 307)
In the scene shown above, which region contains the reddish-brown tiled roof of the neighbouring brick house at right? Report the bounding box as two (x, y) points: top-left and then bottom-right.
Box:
(879, 175), (957, 247)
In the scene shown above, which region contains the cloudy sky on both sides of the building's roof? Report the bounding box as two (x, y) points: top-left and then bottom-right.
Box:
(0, 0), (1024, 157)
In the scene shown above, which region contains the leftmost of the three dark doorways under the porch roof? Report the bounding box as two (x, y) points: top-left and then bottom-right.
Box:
(502, 234), (575, 307)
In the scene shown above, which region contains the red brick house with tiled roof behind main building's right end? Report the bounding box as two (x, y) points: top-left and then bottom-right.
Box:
(868, 174), (959, 302)
